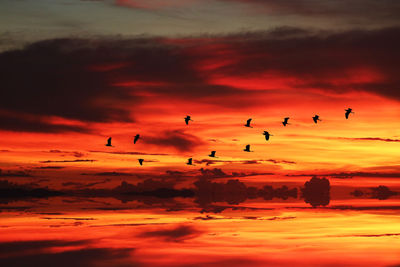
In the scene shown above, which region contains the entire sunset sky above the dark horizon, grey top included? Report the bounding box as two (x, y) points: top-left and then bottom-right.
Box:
(0, 0), (400, 182)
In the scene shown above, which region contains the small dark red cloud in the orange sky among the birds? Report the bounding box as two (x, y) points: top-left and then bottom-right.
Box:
(142, 130), (205, 152)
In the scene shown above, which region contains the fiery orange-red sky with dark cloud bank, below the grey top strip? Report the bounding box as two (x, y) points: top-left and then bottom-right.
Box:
(0, 29), (400, 181)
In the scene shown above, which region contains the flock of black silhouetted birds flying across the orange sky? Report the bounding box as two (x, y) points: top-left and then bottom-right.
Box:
(106, 108), (354, 165)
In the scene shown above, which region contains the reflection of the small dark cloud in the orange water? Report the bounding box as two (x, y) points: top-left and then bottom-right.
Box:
(138, 224), (203, 242)
